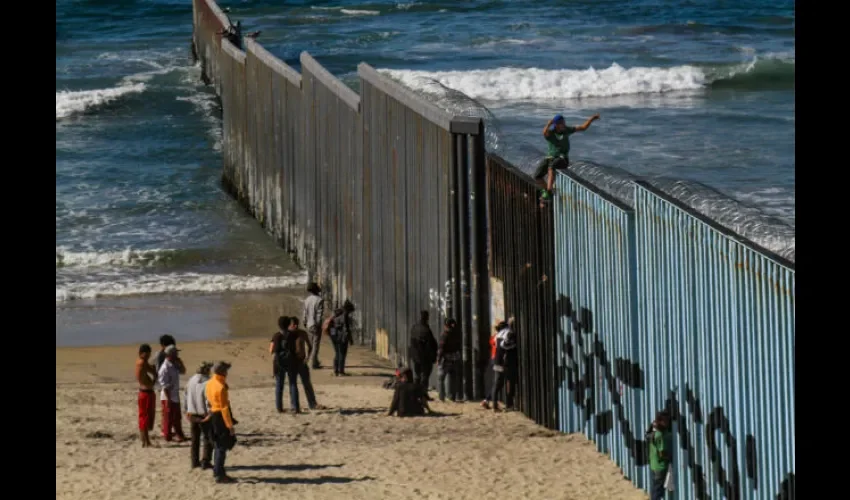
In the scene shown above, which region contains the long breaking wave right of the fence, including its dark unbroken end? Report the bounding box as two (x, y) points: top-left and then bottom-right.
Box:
(380, 57), (794, 101)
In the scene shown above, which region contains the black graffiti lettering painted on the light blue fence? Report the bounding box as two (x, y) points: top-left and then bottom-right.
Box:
(558, 295), (795, 500)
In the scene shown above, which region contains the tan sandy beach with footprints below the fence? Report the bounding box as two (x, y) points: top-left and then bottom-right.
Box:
(56, 337), (647, 500)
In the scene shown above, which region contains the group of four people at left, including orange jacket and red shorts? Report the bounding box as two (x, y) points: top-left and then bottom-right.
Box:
(136, 335), (238, 483)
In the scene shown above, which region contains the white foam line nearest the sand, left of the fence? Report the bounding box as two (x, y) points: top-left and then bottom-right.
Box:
(56, 273), (307, 302)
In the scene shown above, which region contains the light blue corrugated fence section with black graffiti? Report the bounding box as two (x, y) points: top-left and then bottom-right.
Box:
(554, 170), (795, 499)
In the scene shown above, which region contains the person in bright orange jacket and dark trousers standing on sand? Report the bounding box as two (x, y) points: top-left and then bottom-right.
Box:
(204, 361), (236, 483)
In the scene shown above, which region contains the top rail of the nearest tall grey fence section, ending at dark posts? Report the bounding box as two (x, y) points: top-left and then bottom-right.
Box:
(357, 63), (482, 135)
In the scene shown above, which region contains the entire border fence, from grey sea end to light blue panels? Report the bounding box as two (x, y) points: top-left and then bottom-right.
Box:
(193, 0), (795, 499)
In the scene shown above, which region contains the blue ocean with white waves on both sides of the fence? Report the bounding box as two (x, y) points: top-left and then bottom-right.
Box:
(56, 0), (795, 344)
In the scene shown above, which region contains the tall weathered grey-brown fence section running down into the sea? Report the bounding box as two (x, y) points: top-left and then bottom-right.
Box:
(193, 0), (489, 386)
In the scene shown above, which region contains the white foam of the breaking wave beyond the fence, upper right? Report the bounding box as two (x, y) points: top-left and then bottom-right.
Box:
(381, 63), (708, 101)
